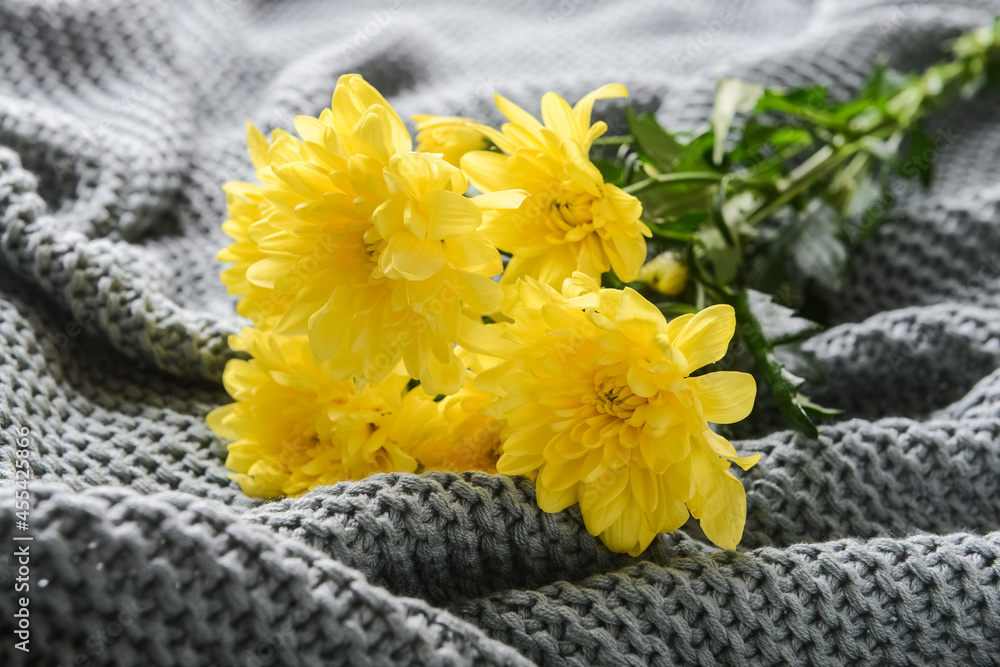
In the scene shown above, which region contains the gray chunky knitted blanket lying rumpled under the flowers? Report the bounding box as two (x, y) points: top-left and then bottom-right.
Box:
(0, 0), (1000, 666)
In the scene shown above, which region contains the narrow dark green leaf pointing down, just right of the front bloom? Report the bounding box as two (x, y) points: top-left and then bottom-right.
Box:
(730, 292), (819, 438)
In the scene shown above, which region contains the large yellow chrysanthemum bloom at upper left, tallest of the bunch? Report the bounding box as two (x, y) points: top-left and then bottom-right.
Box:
(223, 74), (524, 393)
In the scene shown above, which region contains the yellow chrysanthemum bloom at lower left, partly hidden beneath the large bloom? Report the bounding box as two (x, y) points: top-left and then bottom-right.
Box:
(208, 328), (448, 498)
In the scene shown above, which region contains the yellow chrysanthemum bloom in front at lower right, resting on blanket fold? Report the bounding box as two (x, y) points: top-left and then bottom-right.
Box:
(477, 274), (760, 555)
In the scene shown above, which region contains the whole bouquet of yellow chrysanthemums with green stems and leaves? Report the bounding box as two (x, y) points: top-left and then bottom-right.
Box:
(209, 24), (1000, 555)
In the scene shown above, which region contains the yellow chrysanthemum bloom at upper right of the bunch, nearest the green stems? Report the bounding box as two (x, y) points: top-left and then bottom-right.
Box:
(462, 84), (651, 288)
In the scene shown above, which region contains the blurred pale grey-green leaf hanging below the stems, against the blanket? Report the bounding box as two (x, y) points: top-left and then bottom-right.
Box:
(792, 200), (848, 290)
